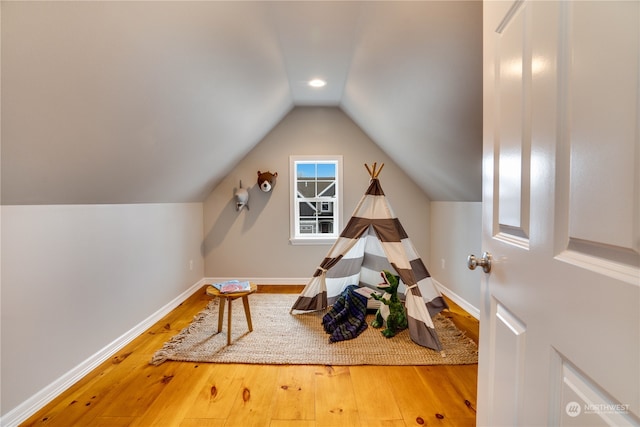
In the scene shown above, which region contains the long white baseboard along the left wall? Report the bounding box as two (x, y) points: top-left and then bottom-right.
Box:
(0, 279), (207, 427)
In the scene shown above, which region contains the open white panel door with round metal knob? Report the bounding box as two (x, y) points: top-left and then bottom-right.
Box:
(475, 1), (640, 427)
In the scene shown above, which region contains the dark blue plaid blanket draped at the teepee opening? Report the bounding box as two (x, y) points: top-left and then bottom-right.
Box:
(322, 285), (367, 342)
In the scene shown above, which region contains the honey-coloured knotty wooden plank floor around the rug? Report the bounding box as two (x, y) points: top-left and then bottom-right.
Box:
(22, 286), (478, 427)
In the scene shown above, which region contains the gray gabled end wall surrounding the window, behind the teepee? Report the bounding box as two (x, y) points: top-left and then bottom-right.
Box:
(203, 107), (430, 282)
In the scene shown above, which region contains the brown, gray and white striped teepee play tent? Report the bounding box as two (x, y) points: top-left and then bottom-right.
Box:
(291, 163), (448, 351)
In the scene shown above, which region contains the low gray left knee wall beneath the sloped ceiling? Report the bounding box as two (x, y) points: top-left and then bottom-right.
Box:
(1, 203), (204, 422)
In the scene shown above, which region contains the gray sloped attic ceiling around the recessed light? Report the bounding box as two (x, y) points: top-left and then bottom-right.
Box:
(0, 1), (482, 204)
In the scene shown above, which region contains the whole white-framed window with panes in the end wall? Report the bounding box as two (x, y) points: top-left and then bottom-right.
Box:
(290, 156), (342, 244)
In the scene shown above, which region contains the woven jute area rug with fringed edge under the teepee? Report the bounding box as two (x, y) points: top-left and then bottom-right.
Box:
(150, 293), (478, 365)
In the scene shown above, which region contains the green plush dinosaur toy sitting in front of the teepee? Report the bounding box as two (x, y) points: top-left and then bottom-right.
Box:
(371, 270), (409, 338)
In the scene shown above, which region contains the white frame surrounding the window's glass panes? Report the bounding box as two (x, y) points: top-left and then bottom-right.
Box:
(289, 155), (343, 245)
